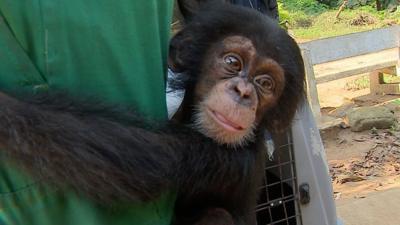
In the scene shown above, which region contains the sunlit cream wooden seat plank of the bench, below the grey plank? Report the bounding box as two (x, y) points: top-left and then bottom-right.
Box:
(314, 48), (399, 84)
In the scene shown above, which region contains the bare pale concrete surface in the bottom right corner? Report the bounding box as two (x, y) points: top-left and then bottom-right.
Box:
(336, 188), (400, 225)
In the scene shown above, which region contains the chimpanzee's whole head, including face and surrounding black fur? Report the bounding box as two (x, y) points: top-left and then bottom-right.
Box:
(169, 5), (305, 146)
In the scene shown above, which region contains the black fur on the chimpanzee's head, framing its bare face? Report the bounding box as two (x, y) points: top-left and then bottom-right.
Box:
(170, 3), (304, 133)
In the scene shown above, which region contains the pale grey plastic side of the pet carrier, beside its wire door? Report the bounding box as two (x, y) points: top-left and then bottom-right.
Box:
(292, 101), (339, 225)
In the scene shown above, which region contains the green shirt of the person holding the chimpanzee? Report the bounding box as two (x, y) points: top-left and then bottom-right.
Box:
(0, 0), (175, 225)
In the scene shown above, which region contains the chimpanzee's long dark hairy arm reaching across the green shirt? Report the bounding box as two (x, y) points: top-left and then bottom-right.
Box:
(0, 93), (216, 201)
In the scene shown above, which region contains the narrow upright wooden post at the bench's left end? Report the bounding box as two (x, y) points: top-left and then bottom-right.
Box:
(302, 47), (321, 121)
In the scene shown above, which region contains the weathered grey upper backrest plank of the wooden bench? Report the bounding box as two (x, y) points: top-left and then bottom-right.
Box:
(300, 25), (400, 65)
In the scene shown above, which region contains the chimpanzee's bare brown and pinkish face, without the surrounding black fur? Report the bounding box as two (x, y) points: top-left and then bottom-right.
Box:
(195, 36), (285, 146)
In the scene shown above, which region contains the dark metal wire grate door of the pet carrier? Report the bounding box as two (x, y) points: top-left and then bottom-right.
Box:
(256, 132), (302, 225)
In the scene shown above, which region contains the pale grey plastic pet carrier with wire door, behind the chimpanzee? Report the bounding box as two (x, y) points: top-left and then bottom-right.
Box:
(256, 103), (342, 225)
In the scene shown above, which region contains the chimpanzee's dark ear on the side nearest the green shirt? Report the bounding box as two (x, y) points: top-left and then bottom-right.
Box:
(168, 31), (193, 73)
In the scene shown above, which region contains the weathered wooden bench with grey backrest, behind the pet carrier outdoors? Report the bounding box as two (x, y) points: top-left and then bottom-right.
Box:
(300, 25), (400, 126)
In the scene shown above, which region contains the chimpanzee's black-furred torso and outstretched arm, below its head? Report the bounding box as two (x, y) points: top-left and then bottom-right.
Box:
(0, 92), (263, 224)
